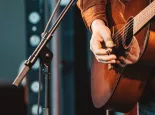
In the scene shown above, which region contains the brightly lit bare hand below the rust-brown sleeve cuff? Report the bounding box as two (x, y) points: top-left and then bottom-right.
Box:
(90, 19), (116, 63)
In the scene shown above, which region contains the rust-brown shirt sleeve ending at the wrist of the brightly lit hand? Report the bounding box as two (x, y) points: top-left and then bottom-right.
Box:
(77, 0), (108, 30)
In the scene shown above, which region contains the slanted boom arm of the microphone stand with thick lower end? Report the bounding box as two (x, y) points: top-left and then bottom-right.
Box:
(13, 0), (75, 86)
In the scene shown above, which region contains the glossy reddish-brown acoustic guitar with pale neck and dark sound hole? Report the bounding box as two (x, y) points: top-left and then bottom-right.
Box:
(91, 0), (155, 112)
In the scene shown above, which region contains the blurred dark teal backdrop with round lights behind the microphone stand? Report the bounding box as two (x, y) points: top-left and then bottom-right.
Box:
(0, 0), (105, 115)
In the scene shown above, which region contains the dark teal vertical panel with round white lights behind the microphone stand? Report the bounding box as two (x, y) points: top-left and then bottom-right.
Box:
(24, 0), (45, 115)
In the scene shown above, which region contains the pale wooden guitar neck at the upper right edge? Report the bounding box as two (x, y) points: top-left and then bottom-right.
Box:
(133, 1), (155, 35)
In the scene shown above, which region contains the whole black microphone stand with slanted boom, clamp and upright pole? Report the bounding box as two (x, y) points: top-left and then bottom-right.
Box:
(13, 0), (76, 115)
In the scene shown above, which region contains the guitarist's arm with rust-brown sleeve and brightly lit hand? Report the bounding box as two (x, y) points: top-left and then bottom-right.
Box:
(77, 0), (116, 63)
